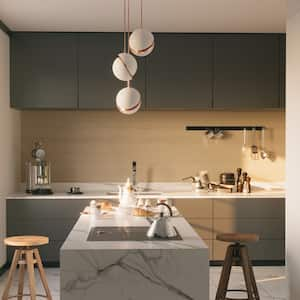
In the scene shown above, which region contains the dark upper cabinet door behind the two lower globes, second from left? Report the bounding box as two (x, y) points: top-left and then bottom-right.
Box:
(78, 33), (145, 109)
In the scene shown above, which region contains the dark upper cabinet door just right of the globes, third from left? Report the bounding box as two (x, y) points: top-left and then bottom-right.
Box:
(146, 34), (213, 109)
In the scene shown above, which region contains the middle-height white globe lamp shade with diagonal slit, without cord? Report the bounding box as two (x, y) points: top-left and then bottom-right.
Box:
(112, 52), (138, 81)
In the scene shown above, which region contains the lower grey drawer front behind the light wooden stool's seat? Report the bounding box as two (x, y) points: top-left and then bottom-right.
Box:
(7, 218), (77, 241)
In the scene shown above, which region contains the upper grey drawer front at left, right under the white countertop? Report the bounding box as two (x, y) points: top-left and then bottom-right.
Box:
(6, 199), (90, 220)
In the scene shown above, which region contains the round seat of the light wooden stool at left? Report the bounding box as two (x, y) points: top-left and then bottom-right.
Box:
(4, 235), (49, 247)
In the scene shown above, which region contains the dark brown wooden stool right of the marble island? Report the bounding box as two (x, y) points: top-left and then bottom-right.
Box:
(216, 233), (259, 300)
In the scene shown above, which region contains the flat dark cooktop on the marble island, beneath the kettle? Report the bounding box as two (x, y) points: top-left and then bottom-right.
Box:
(87, 226), (182, 242)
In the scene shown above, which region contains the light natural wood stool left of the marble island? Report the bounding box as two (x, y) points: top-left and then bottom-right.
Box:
(2, 236), (52, 300)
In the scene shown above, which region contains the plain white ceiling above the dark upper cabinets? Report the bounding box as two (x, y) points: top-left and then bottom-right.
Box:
(0, 0), (287, 32)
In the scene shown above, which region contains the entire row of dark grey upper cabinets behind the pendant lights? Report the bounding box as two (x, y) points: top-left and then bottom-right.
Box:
(10, 32), (285, 110)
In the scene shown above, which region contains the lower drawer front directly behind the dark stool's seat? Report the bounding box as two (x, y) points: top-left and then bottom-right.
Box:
(214, 219), (285, 240)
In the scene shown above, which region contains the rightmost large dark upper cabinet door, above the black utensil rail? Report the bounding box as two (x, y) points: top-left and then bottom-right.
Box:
(214, 34), (283, 109)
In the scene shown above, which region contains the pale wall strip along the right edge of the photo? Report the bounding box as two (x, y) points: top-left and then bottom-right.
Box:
(286, 0), (300, 300)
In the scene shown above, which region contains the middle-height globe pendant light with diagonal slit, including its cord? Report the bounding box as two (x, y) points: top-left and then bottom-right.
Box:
(112, 0), (138, 81)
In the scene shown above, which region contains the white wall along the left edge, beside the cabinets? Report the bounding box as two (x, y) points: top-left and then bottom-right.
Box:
(0, 30), (20, 267)
